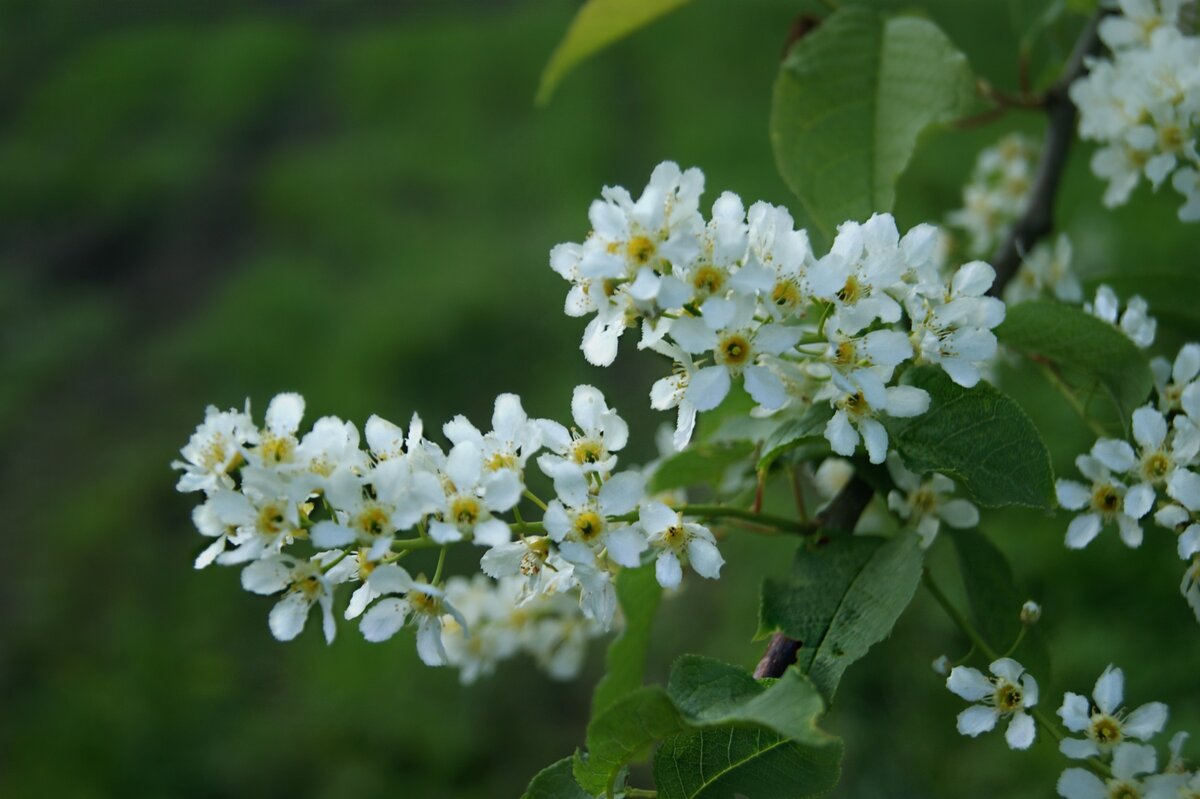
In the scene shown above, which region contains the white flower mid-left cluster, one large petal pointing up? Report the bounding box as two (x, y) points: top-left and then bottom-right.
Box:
(430, 440), (523, 547)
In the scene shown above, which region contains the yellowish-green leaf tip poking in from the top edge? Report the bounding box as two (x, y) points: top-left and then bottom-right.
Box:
(535, 0), (691, 106)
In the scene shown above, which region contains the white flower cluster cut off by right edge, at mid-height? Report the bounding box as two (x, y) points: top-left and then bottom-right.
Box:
(1056, 344), (1200, 619)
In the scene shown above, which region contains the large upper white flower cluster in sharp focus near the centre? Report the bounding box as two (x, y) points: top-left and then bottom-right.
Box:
(550, 162), (1004, 463)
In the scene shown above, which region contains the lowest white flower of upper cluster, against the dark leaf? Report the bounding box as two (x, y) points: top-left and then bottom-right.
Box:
(816, 370), (929, 463)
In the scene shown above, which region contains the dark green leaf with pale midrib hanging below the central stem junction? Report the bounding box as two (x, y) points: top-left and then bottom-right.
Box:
(758, 535), (925, 701)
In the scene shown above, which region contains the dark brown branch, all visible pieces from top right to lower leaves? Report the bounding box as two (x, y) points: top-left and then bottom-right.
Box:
(754, 10), (1108, 679)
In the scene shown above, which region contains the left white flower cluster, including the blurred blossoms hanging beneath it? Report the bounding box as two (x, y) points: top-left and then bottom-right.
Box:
(174, 385), (724, 680)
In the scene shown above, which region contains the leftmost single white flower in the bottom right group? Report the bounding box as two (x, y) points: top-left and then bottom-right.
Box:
(946, 657), (1038, 749)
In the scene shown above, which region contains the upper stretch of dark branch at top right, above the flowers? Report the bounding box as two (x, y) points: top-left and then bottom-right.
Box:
(989, 11), (1106, 296)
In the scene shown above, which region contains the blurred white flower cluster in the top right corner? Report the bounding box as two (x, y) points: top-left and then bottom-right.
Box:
(1070, 0), (1200, 222)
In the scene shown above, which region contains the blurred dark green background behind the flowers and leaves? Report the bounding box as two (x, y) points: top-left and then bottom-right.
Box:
(0, 0), (1200, 799)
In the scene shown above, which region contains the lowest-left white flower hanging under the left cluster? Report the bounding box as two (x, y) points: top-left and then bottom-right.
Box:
(241, 552), (354, 643)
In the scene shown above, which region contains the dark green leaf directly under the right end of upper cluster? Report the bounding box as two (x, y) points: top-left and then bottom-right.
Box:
(884, 364), (1054, 507)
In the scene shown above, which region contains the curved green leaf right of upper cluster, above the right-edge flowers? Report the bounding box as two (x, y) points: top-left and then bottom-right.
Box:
(996, 300), (1154, 420)
